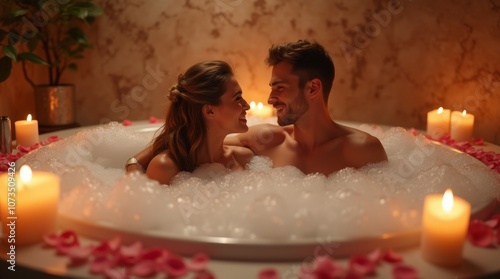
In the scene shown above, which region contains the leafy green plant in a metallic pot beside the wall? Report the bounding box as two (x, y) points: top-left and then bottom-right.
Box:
(0, 0), (102, 126)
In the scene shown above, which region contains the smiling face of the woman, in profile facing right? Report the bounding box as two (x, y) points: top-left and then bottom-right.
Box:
(214, 77), (250, 133)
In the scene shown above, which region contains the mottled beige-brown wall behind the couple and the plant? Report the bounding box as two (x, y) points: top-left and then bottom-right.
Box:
(0, 0), (500, 144)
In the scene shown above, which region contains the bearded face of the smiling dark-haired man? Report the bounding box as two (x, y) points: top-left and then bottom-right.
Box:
(267, 62), (309, 126)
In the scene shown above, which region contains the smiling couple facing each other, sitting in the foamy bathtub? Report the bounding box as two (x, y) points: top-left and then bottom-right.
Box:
(126, 40), (387, 184)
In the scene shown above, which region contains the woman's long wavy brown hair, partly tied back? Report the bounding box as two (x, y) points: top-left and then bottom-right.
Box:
(153, 61), (233, 171)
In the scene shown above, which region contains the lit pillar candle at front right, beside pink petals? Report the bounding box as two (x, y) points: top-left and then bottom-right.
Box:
(420, 189), (470, 266)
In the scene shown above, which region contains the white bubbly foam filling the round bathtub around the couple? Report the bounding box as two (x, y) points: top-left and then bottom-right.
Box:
(19, 123), (500, 259)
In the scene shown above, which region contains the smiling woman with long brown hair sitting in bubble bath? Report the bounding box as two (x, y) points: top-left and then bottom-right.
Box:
(146, 61), (253, 184)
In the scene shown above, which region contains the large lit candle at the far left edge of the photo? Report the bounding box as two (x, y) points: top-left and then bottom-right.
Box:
(0, 165), (59, 246)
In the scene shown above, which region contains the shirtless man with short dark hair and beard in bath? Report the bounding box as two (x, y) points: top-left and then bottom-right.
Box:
(127, 40), (387, 175)
